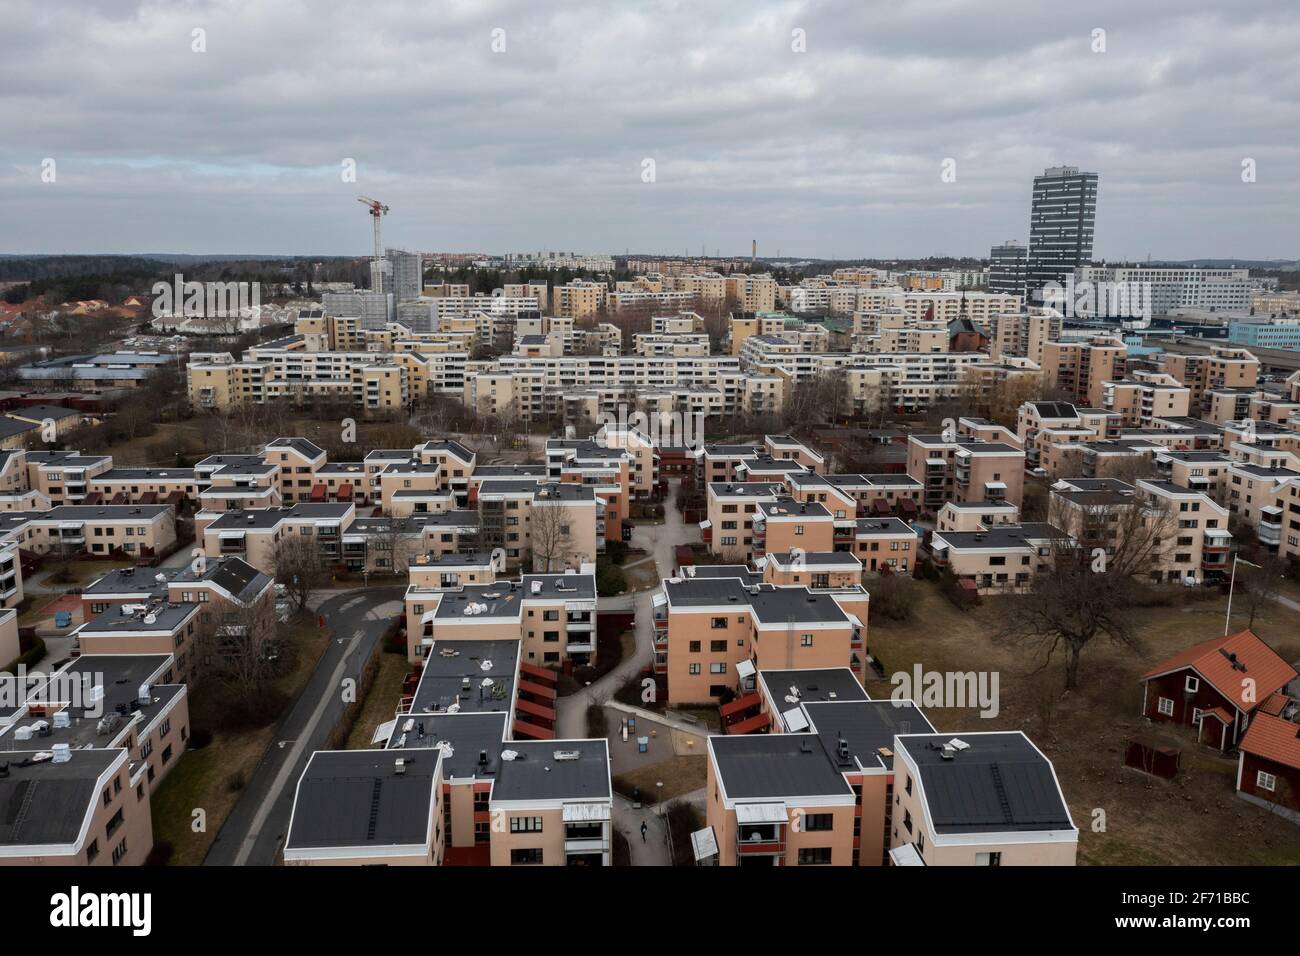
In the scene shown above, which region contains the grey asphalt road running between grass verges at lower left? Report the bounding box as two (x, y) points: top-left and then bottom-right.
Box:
(203, 588), (403, 866)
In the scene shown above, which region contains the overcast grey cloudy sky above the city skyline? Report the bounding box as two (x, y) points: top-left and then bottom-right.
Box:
(0, 0), (1300, 259)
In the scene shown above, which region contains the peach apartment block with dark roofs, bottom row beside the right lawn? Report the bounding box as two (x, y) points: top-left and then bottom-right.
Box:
(706, 669), (1078, 866)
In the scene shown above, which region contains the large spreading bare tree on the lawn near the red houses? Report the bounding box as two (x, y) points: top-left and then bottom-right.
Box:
(996, 498), (1177, 691)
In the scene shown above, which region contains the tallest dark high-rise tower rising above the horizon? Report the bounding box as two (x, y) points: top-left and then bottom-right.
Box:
(1026, 166), (1097, 300)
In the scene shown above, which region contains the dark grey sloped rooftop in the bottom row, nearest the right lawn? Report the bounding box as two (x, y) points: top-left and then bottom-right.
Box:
(898, 732), (1073, 834)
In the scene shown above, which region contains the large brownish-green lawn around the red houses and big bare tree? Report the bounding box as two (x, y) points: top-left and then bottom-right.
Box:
(867, 581), (1300, 865)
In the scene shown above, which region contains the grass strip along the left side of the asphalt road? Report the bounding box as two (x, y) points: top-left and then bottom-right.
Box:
(150, 622), (332, 866)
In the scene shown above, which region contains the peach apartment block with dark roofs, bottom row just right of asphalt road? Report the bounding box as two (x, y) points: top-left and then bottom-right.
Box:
(285, 641), (614, 866)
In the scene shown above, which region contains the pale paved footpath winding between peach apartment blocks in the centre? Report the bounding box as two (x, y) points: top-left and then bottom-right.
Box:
(555, 497), (699, 738)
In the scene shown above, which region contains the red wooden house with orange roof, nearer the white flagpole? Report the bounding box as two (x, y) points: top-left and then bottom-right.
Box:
(1141, 631), (1296, 750)
